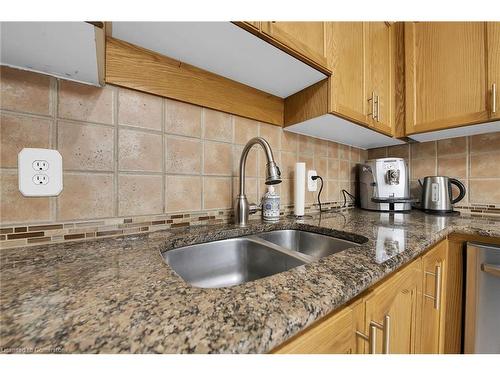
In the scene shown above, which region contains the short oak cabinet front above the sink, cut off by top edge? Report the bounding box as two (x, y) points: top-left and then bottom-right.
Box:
(261, 21), (327, 68)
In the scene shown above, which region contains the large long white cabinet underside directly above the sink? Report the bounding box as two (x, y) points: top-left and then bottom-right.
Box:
(112, 22), (326, 98)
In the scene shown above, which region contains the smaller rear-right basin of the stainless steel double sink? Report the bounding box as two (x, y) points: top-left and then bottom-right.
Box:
(255, 229), (358, 259)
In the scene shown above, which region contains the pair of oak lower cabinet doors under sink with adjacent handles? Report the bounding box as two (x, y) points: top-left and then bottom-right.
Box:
(272, 258), (422, 354)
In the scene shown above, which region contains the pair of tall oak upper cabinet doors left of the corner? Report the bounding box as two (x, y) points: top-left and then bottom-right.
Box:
(325, 22), (395, 135)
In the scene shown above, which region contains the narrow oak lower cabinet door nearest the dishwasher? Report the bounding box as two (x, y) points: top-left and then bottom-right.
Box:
(420, 241), (447, 354)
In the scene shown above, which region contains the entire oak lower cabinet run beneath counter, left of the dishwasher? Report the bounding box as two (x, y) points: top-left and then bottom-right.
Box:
(272, 239), (464, 354)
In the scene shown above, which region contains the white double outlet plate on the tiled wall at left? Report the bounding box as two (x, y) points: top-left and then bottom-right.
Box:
(17, 148), (63, 197)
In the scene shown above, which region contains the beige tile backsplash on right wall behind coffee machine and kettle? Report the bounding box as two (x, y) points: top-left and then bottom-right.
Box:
(368, 132), (500, 207)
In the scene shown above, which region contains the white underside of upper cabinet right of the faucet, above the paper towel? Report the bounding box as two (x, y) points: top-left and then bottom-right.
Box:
(285, 114), (404, 150)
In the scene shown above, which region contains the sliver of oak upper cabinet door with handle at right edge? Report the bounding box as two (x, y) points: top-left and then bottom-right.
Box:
(486, 22), (500, 119)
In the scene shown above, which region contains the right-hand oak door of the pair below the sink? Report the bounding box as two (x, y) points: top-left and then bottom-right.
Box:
(364, 258), (422, 354)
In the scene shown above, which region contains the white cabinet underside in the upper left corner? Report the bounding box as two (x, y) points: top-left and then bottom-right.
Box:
(0, 22), (99, 85)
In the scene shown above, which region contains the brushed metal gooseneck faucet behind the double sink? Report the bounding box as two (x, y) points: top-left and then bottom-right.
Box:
(234, 137), (281, 226)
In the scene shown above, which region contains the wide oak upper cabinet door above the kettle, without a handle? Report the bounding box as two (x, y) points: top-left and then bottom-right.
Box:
(405, 22), (489, 134)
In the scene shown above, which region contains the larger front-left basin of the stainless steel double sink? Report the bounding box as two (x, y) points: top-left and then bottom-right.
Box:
(162, 237), (306, 288)
